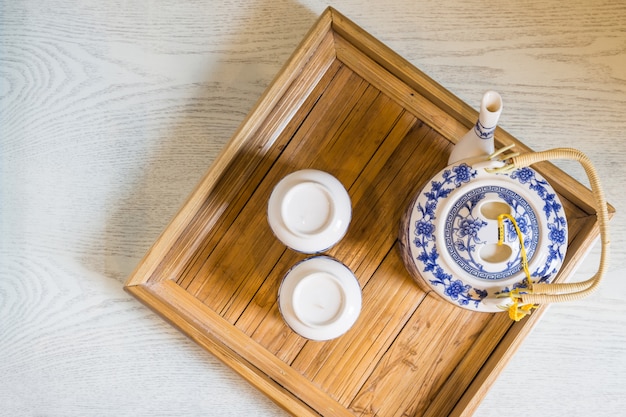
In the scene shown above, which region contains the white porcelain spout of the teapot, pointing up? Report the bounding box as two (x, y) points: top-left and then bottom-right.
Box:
(448, 91), (502, 165)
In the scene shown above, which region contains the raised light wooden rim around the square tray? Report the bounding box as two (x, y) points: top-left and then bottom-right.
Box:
(125, 7), (614, 416)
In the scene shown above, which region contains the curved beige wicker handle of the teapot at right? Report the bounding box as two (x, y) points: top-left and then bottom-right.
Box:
(494, 147), (609, 305)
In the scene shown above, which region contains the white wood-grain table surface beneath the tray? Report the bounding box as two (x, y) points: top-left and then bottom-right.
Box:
(0, 0), (626, 417)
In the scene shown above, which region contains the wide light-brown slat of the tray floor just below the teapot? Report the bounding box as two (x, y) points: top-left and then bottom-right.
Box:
(350, 297), (491, 416)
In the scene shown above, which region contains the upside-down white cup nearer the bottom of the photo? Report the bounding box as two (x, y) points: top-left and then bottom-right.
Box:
(278, 256), (361, 341)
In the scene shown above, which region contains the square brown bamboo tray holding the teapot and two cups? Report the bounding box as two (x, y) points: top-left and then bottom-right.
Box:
(125, 8), (598, 416)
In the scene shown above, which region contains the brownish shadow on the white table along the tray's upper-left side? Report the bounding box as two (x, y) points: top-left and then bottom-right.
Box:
(104, 0), (317, 283)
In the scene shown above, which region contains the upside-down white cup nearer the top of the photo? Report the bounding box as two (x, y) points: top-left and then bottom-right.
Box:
(267, 169), (352, 253)
